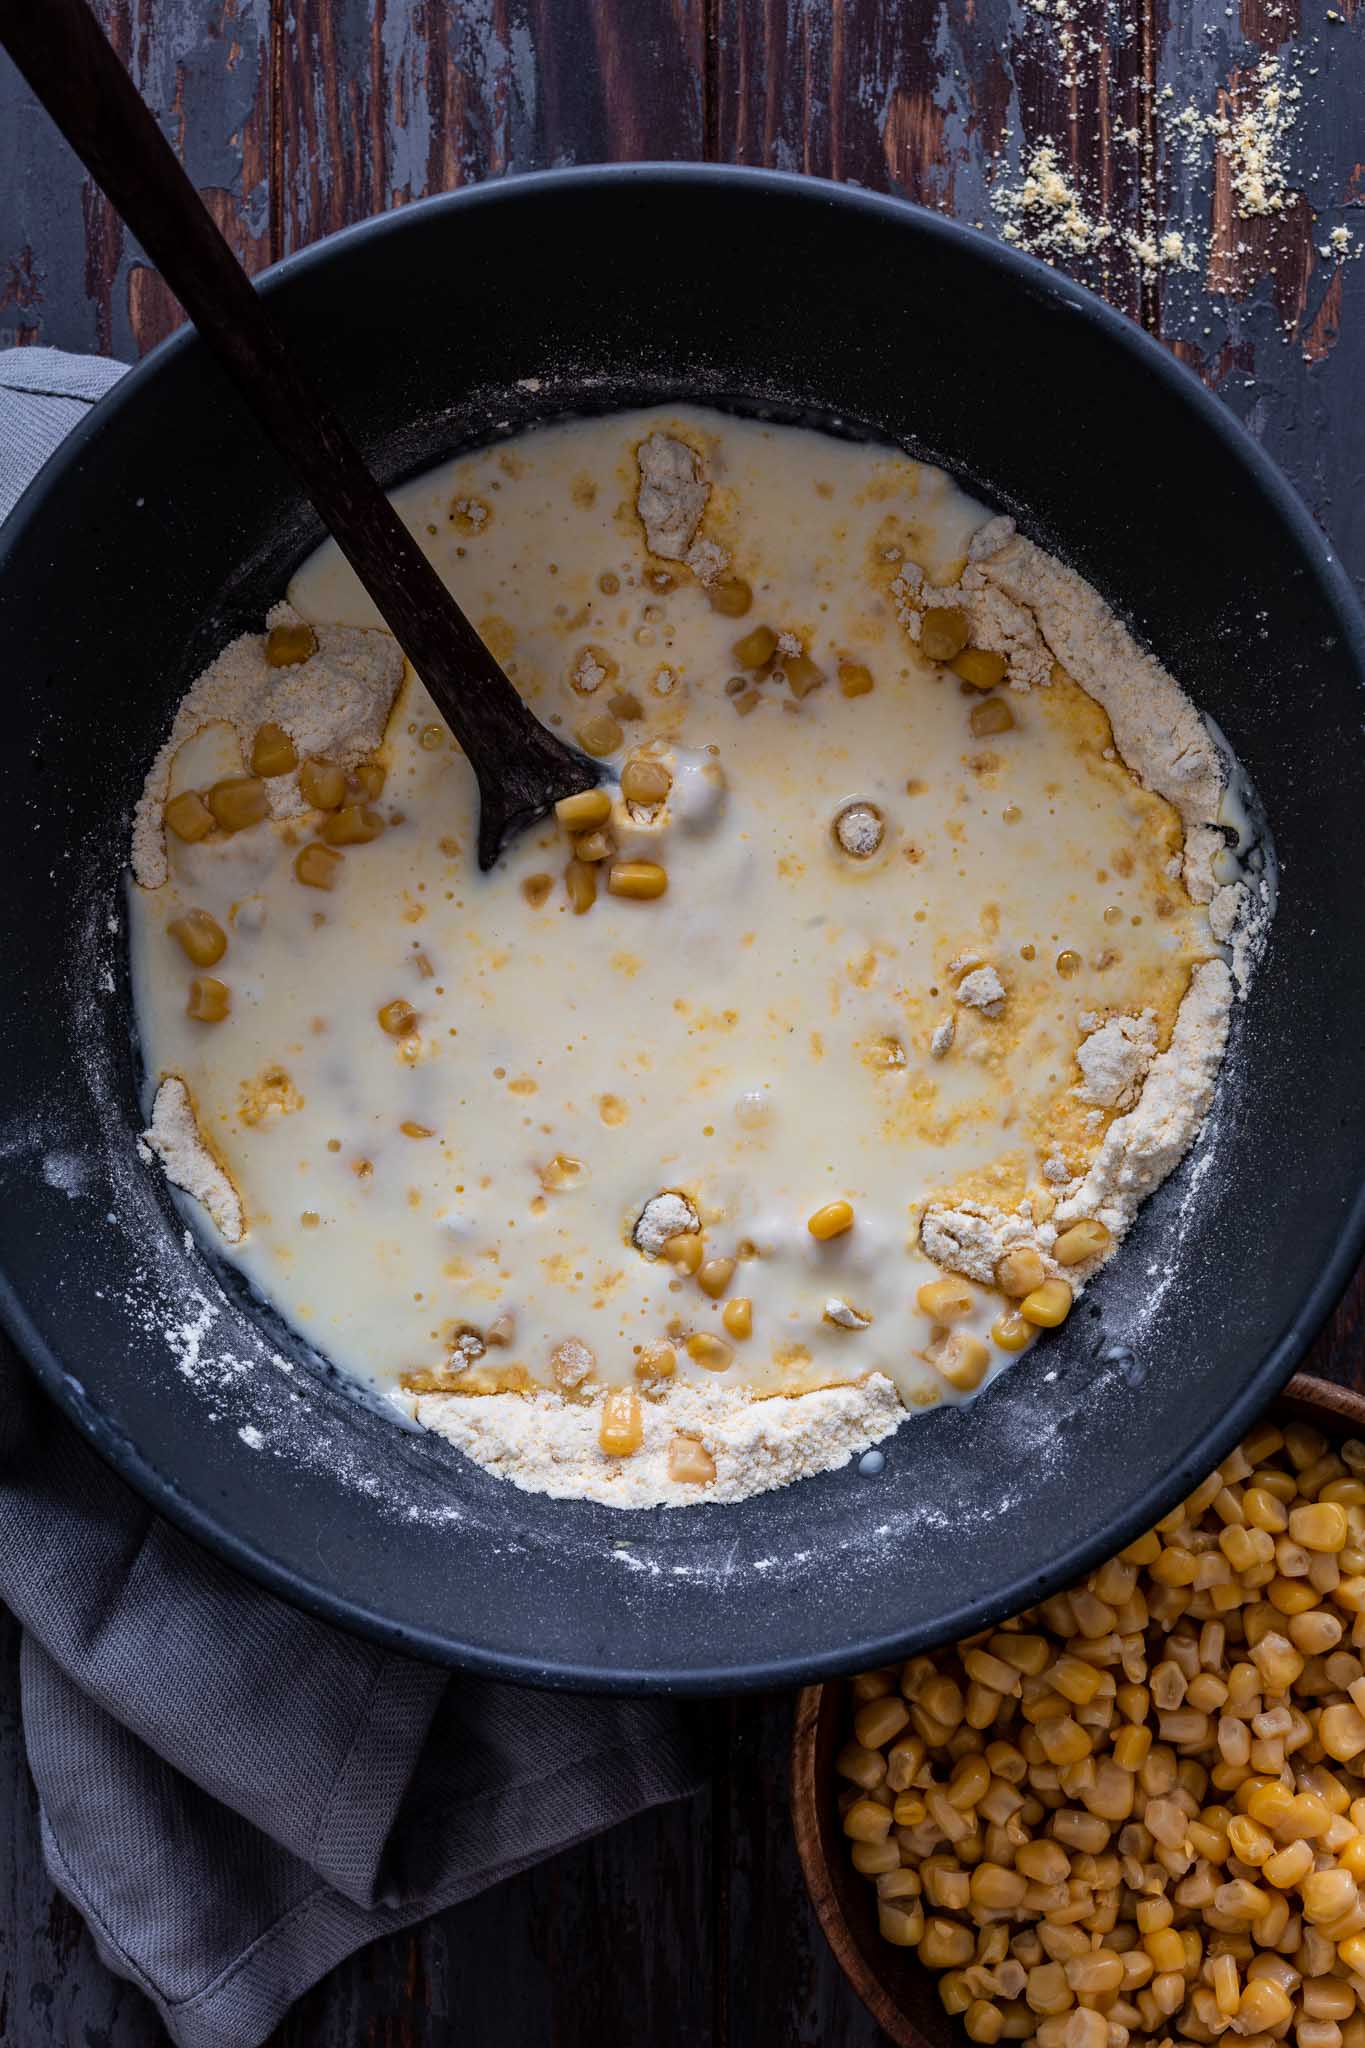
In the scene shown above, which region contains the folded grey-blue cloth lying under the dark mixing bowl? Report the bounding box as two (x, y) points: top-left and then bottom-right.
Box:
(0, 348), (700, 2048)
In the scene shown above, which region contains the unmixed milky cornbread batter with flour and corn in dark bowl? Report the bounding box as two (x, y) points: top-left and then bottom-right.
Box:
(131, 412), (1246, 1505)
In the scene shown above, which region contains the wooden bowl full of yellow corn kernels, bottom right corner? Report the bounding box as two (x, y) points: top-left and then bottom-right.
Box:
(792, 1378), (1365, 2048)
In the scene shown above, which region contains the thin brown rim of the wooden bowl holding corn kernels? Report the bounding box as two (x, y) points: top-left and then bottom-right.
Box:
(790, 1372), (1365, 2048)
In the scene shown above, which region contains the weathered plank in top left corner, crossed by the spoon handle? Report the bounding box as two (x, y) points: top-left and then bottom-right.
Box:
(0, 0), (272, 358)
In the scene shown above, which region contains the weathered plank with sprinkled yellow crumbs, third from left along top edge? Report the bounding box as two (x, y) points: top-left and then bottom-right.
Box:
(716, 0), (1146, 313)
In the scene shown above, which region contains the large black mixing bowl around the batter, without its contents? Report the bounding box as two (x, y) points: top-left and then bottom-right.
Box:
(0, 166), (1365, 1690)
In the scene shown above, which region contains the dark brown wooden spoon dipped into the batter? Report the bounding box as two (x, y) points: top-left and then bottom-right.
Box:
(0, 0), (602, 868)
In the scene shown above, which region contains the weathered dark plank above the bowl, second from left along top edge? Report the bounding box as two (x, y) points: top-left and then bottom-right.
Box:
(276, 0), (704, 248)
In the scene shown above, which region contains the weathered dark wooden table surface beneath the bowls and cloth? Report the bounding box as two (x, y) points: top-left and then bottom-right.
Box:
(0, 0), (1365, 2048)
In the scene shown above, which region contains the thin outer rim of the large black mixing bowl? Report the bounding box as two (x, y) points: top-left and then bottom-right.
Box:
(0, 162), (1365, 1694)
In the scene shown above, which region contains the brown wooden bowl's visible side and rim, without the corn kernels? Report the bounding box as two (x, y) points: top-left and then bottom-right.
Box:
(792, 1374), (1365, 2048)
